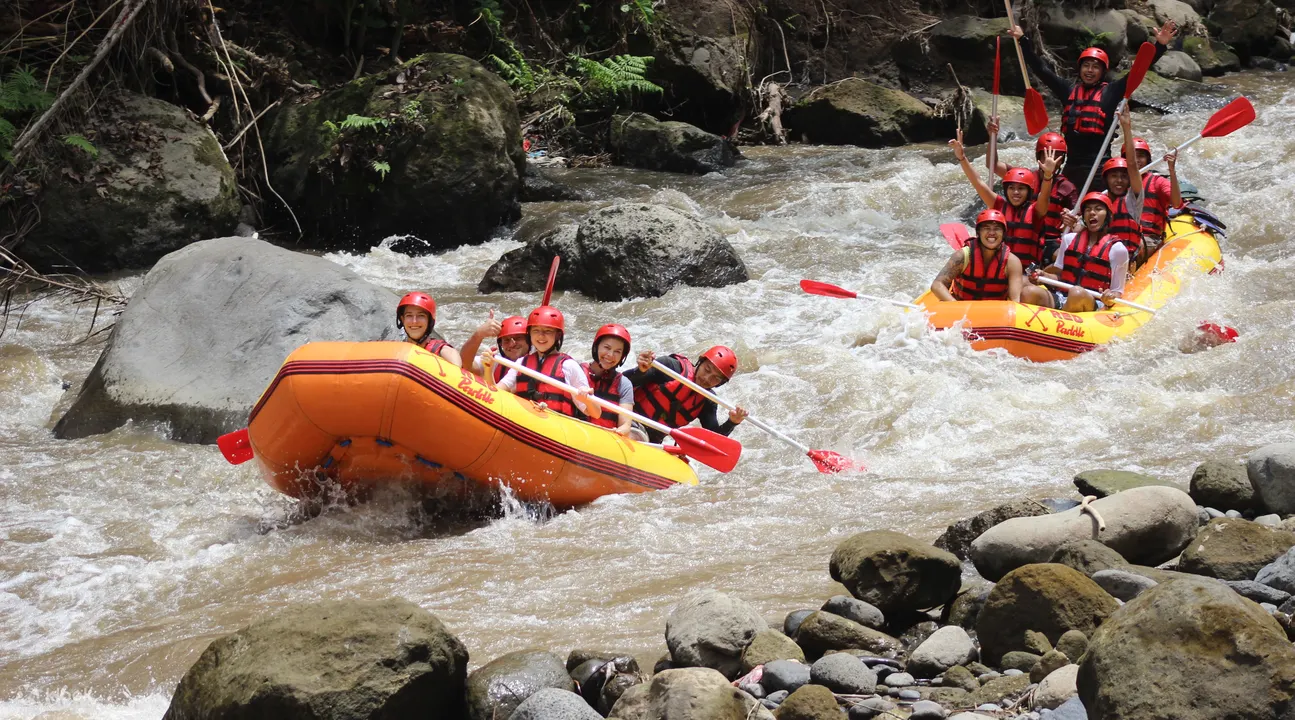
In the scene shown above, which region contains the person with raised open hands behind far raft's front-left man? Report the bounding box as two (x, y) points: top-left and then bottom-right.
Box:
(949, 129), (1059, 269)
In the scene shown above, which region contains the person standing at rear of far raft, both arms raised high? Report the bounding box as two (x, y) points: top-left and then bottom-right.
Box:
(1011, 19), (1178, 190)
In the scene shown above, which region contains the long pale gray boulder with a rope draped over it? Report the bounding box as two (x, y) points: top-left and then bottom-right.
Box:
(970, 487), (1198, 580)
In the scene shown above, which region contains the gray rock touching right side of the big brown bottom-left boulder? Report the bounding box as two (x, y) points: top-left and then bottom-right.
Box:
(467, 650), (575, 720)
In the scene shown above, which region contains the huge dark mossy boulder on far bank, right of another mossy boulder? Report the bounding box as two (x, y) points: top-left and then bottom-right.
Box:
(262, 53), (526, 253)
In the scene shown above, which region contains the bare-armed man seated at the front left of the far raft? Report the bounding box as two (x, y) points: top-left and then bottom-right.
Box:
(931, 210), (1048, 304)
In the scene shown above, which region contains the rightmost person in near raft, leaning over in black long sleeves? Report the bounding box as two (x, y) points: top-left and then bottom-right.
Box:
(625, 344), (747, 443)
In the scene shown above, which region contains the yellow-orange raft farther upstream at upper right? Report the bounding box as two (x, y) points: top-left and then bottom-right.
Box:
(913, 212), (1222, 363)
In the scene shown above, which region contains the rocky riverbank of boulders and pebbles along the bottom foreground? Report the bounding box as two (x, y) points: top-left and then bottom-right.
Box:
(166, 443), (1295, 720)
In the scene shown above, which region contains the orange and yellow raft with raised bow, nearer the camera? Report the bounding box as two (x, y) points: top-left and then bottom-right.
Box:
(247, 342), (697, 508)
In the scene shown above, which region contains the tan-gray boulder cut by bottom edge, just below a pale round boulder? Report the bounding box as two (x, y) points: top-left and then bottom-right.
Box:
(609, 667), (773, 720)
